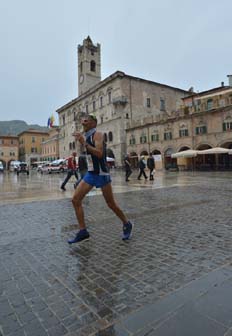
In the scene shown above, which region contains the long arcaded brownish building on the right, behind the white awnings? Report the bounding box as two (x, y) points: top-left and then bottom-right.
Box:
(126, 79), (232, 169)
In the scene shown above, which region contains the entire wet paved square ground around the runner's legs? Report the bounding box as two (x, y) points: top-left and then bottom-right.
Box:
(0, 171), (232, 336)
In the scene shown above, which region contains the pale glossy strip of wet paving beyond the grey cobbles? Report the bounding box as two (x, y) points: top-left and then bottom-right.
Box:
(0, 170), (231, 204)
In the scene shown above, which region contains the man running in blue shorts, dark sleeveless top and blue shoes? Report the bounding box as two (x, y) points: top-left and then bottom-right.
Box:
(68, 114), (133, 244)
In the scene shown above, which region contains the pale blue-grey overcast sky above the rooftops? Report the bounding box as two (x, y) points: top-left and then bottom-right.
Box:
(0, 0), (232, 126)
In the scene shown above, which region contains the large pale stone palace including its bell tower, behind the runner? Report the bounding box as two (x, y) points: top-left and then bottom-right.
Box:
(57, 37), (189, 166)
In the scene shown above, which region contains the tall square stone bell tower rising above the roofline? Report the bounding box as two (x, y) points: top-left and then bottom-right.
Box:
(78, 36), (101, 96)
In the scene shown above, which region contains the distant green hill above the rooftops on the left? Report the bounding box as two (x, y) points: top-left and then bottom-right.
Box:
(0, 120), (48, 135)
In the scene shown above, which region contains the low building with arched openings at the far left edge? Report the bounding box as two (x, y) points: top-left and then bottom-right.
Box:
(0, 135), (19, 169)
